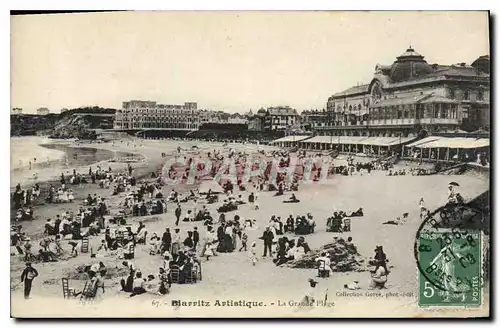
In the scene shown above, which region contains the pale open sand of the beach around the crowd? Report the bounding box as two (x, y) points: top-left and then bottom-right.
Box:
(11, 140), (489, 317)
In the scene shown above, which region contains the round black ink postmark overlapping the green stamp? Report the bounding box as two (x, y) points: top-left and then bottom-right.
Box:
(414, 204), (484, 294)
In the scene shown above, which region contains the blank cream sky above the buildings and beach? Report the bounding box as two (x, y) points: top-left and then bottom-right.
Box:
(11, 11), (489, 113)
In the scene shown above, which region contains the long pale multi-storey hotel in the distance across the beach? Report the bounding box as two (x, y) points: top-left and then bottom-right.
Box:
(113, 100), (199, 131)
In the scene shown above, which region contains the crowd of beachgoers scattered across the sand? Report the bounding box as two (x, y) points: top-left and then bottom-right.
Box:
(11, 140), (457, 304)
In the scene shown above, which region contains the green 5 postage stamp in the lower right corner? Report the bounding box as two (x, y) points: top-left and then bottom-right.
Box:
(417, 229), (482, 306)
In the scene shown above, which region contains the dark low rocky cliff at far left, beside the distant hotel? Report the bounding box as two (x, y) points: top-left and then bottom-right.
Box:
(10, 107), (115, 139)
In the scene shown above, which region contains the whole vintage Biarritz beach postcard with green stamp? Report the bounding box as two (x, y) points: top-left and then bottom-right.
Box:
(10, 11), (491, 318)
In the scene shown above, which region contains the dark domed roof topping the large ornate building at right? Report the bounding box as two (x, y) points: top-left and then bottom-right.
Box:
(390, 47), (433, 82)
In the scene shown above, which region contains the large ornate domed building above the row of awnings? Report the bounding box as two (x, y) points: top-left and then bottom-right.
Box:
(314, 48), (490, 137)
